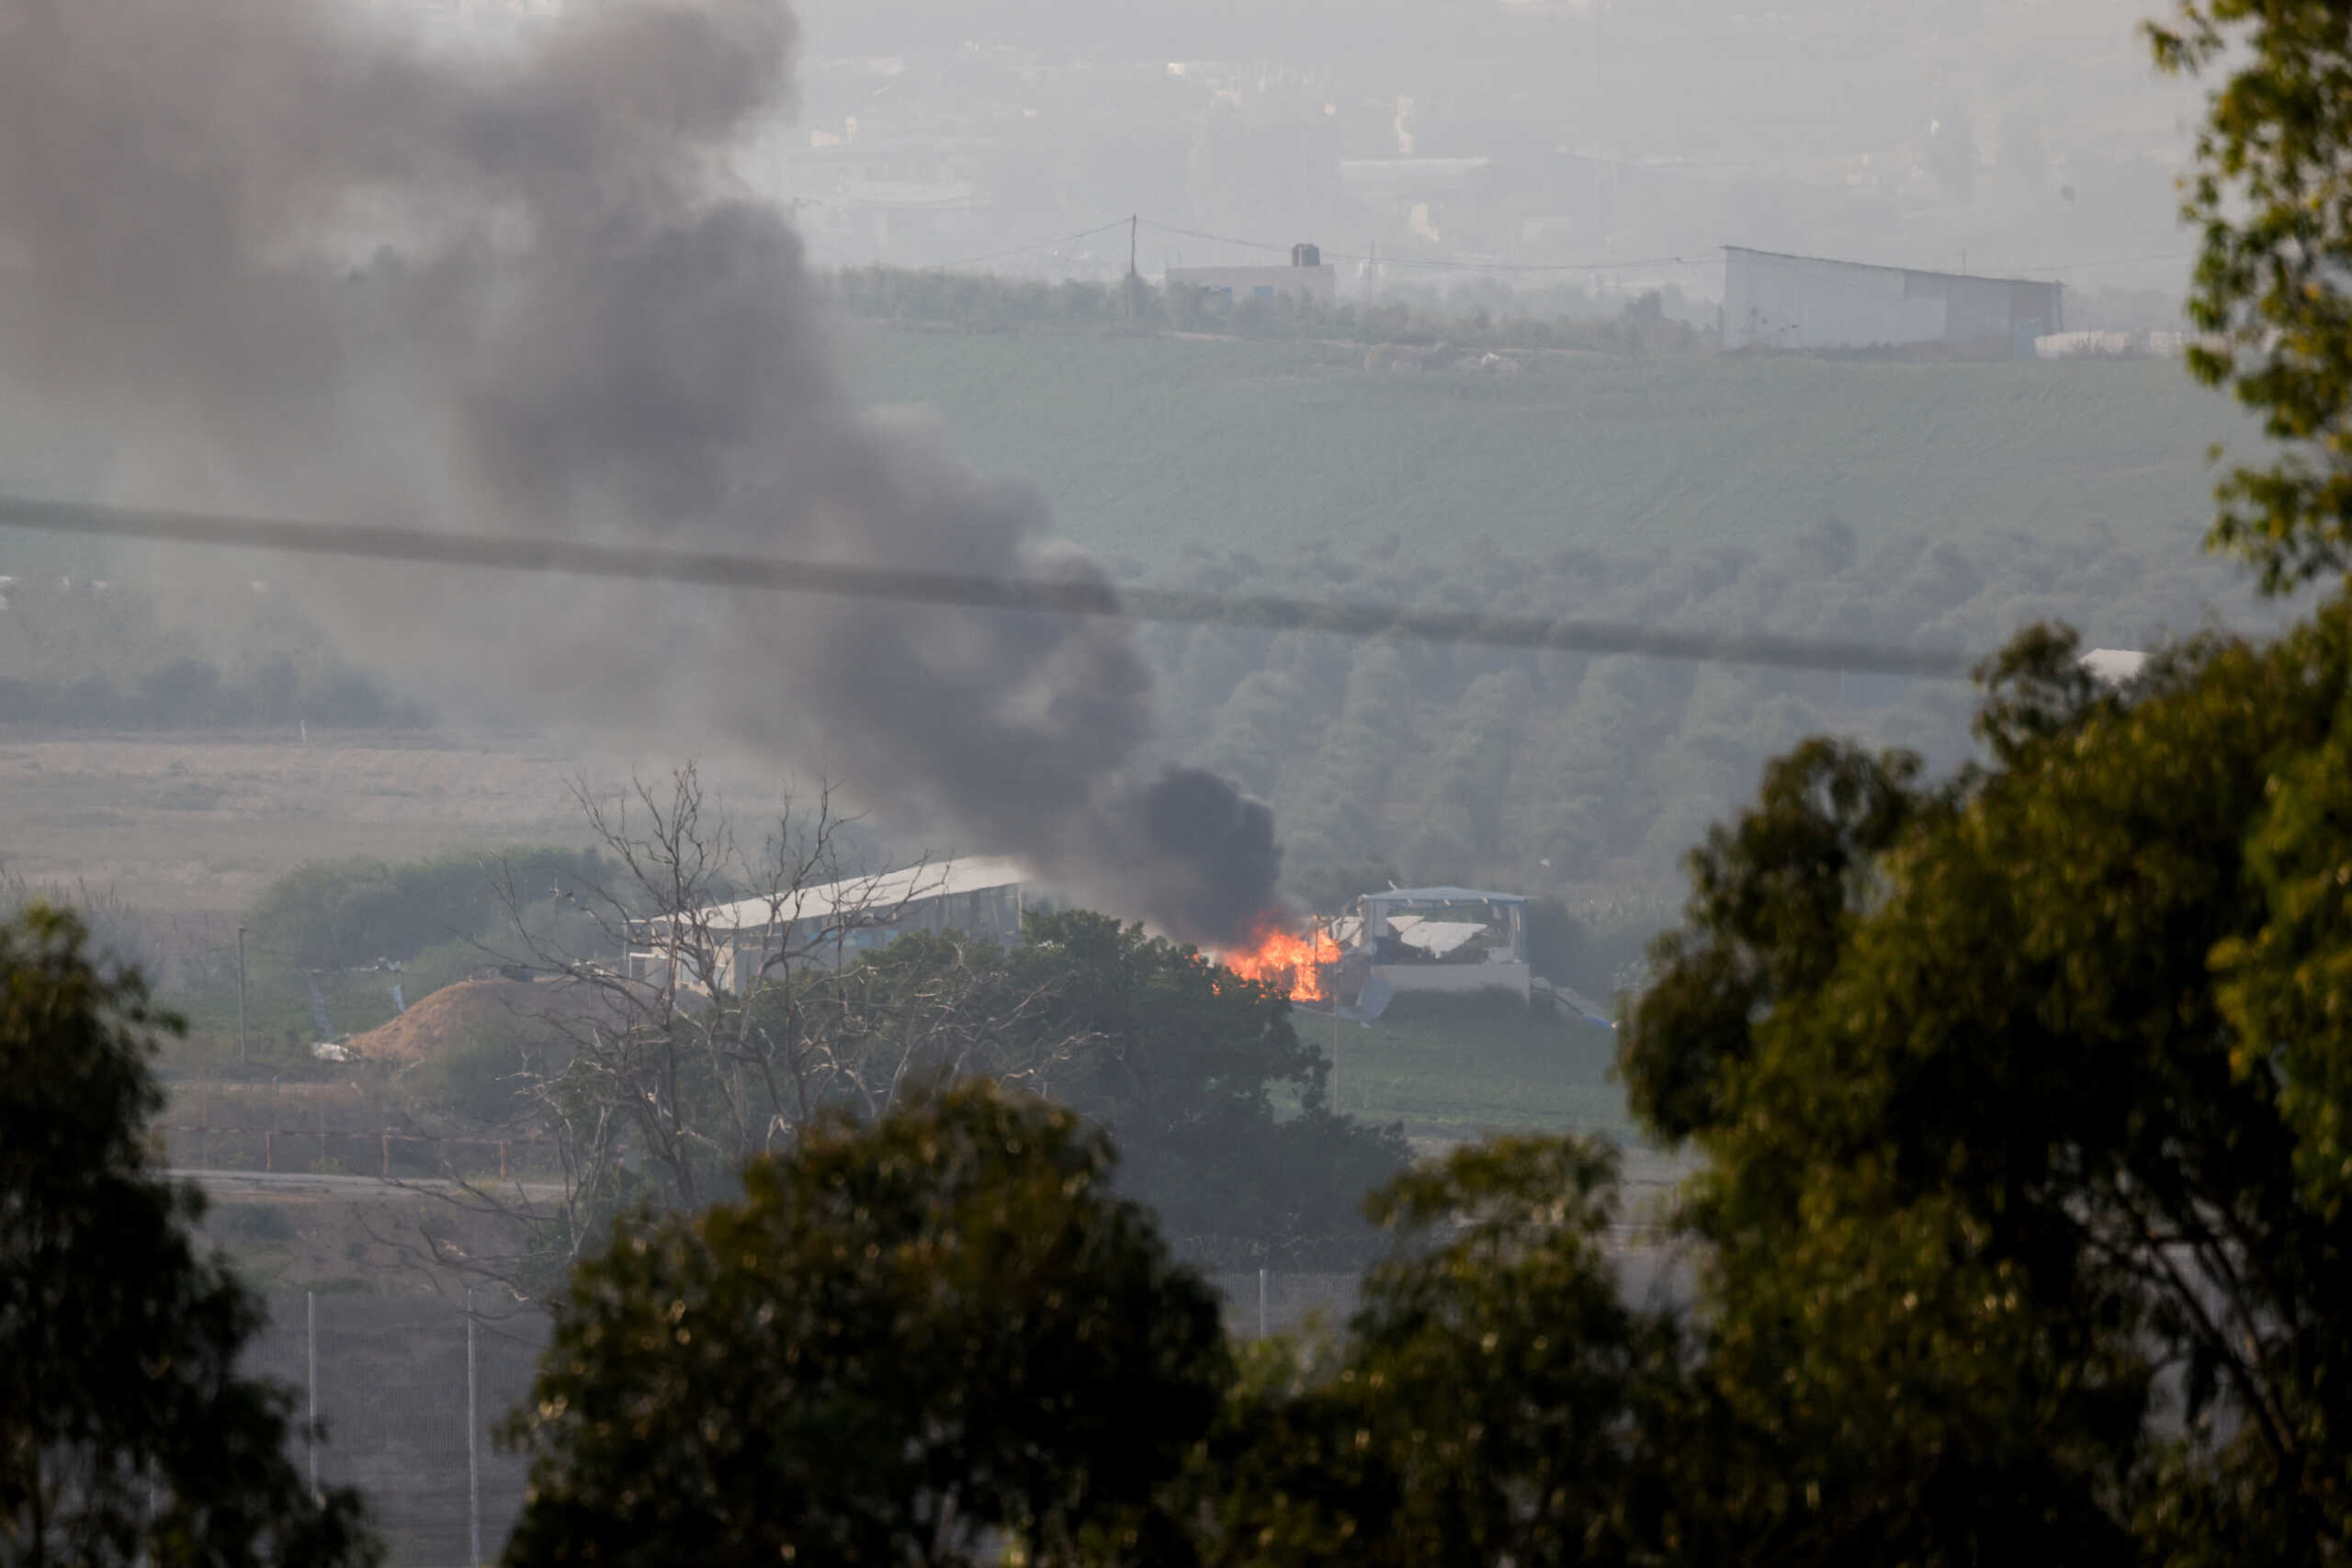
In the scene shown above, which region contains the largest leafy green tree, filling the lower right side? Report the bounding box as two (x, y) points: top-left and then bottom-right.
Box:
(1623, 620), (2352, 1561)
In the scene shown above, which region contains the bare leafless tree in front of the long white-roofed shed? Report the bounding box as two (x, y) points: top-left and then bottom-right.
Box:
(388, 764), (1084, 1295)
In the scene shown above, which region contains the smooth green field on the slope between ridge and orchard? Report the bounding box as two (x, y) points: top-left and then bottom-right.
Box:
(847, 327), (2248, 571)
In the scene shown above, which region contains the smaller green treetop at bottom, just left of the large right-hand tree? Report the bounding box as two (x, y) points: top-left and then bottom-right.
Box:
(1173, 1138), (1684, 1568)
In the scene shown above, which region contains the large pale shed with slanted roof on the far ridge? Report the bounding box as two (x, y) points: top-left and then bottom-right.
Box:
(1724, 244), (2065, 360)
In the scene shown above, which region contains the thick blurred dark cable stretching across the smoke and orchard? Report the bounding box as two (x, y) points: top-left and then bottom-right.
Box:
(0, 496), (1973, 680)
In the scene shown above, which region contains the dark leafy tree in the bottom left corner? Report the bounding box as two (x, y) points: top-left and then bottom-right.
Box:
(0, 908), (374, 1568)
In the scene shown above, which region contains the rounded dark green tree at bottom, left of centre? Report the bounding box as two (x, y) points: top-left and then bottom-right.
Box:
(505, 1084), (1230, 1568)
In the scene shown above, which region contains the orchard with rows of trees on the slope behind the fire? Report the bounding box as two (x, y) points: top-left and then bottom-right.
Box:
(1146, 522), (2267, 931)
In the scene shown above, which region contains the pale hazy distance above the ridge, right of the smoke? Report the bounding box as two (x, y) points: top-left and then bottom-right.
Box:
(748, 0), (2197, 287)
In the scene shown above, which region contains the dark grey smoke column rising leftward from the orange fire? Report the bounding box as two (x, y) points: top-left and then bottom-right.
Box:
(0, 0), (1277, 941)
